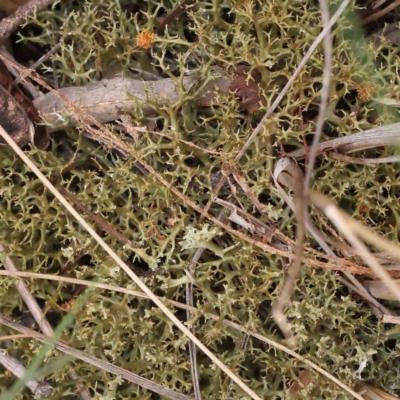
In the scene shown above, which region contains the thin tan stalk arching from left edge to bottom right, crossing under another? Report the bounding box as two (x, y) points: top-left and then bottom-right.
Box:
(0, 270), (364, 400)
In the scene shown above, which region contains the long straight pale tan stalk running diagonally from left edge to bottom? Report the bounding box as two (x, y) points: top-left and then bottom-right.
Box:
(0, 126), (261, 400)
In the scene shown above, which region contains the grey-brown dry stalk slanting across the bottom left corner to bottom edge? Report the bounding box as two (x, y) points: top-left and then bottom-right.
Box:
(0, 315), (194, 400)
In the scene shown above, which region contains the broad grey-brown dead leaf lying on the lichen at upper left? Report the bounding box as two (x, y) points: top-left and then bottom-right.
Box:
(33, 71), (232, 130)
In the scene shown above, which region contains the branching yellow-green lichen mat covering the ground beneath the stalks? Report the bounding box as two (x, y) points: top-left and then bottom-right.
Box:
(0, 0), (400, 400)
